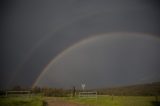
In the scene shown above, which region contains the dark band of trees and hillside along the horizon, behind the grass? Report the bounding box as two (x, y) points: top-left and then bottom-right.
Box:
(0, 82), (160, 97)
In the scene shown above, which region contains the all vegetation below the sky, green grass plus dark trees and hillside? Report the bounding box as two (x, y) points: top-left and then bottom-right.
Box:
(0, 82), (160, 106)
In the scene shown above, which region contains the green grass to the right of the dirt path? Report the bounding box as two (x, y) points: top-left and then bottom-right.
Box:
(65, 96), (160, 106)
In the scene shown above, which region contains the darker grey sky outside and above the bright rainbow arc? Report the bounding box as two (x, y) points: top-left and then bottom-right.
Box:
(1, 0), (160, 86)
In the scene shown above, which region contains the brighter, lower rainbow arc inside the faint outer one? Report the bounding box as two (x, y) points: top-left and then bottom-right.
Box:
(32, 32), (160, 87)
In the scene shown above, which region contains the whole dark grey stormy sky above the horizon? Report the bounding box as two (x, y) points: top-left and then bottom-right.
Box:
(0, 0), (160, 88)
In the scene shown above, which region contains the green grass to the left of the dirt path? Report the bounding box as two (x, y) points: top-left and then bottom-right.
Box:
(0, 96), (43, 106)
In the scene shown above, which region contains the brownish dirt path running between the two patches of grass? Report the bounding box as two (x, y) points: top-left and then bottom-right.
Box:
(45, 98), (84, 106)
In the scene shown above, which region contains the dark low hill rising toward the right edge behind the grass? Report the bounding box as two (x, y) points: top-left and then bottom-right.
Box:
(97, 82), (160, 96)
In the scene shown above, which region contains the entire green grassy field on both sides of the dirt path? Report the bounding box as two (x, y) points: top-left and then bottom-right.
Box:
(0, 96), (160, 106)
